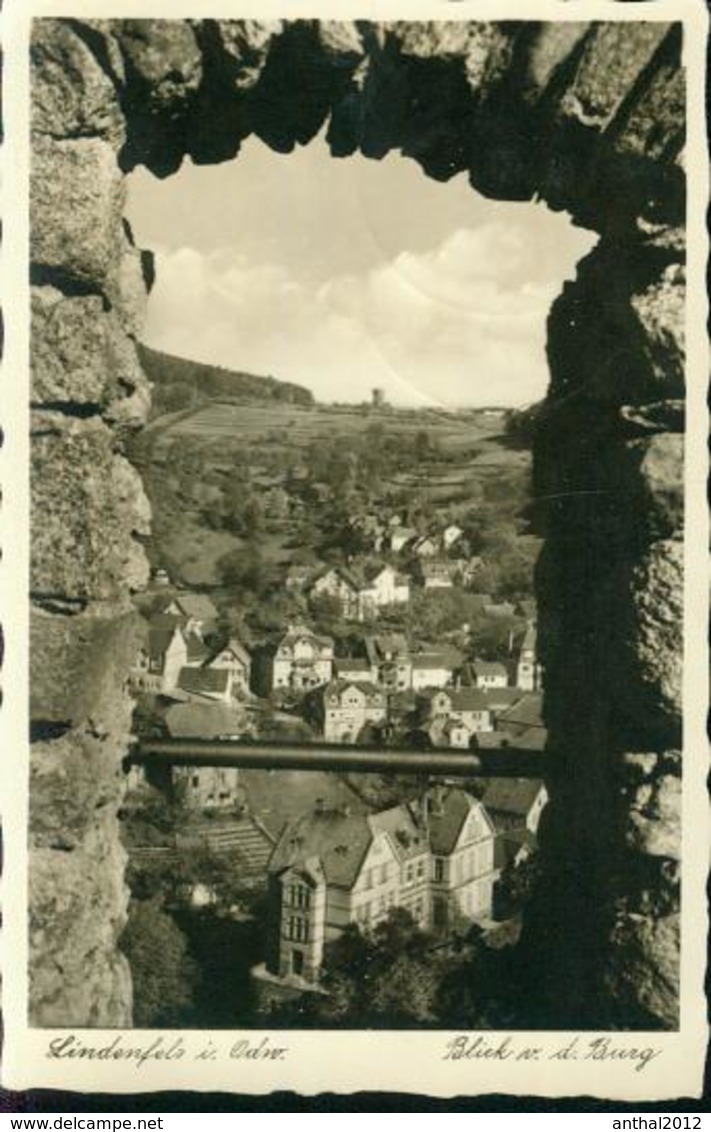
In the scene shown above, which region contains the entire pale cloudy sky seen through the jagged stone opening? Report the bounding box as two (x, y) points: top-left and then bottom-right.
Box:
(127, 138), (594, 406)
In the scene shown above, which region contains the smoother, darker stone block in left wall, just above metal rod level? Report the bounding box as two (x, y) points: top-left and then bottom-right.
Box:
(29, 606), (145, 734)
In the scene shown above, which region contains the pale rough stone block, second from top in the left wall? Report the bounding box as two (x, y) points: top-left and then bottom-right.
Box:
(31, 137), (125, 291)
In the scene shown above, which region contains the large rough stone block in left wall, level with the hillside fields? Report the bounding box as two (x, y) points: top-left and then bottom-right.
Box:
(31, 414), (151, 600)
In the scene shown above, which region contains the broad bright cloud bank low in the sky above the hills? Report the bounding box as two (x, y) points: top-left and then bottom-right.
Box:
(141, 221), (584, 404)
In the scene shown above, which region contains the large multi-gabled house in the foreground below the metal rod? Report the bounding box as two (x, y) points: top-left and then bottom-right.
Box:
(266, 788), (497, 985)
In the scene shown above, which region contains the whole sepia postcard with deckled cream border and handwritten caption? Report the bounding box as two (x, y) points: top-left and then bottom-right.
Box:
(3, 0), (709, 1098)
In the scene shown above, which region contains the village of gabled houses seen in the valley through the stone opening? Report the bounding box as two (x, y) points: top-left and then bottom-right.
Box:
(127, 509), (546, 1009)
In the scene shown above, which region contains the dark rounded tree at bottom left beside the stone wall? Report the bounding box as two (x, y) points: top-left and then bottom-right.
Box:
(121, 897), (198, 1027)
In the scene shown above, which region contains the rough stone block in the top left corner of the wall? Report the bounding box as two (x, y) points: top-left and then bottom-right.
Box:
(29, 19), (126, 146)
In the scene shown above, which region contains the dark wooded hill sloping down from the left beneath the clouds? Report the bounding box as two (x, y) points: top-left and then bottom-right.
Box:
(138, 344), (314, 417)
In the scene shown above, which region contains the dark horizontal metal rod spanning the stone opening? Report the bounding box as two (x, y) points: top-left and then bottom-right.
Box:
(127, 739), (554, 778)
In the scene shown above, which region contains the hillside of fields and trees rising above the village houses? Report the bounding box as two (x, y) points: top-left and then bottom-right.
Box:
(132, 369), (537, 609)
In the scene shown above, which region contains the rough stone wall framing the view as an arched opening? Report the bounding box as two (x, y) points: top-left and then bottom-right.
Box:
(31, 19), (685, 1027)
